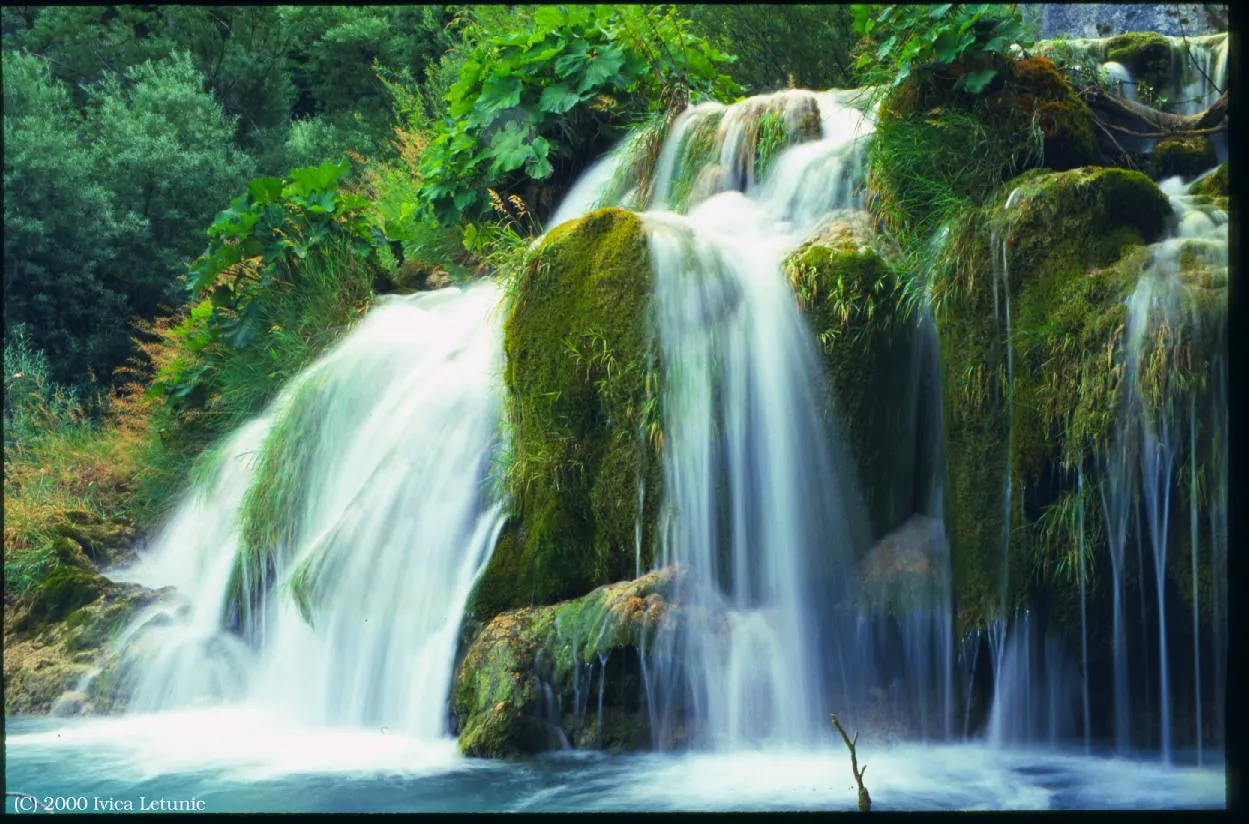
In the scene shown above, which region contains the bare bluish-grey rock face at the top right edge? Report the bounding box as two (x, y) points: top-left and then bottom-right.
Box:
(1024, 2), (1228, 39)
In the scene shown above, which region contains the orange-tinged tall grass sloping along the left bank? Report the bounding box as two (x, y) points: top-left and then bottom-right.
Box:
(4, 234), (372, 601)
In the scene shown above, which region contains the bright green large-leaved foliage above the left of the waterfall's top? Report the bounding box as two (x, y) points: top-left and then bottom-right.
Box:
(420, 6), (736, 222)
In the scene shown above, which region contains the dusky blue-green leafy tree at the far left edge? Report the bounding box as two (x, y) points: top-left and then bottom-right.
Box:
(4, 50), (146, 387)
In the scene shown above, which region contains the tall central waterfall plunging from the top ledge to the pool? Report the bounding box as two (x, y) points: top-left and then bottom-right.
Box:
(619, 92), (871, 749)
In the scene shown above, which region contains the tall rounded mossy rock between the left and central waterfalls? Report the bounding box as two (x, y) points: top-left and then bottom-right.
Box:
(468, 208), (661, 620)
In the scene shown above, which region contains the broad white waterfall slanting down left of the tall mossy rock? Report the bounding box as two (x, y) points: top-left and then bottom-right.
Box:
(107, 283), (501, 740)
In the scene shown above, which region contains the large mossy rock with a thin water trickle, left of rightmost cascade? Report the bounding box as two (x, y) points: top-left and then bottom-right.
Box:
(939, 169), (1170, 628)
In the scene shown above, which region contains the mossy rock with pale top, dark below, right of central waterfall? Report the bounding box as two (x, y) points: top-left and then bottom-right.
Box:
(784, 212), (933, 538)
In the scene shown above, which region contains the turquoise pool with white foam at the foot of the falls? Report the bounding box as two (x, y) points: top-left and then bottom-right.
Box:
(5, 710), (1227, 813)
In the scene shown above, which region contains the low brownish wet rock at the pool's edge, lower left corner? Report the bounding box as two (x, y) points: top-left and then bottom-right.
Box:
(4, 579), (171, 715)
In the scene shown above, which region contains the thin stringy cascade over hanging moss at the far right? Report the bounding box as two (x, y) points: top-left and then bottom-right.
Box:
(1103, 171), (1227, 763)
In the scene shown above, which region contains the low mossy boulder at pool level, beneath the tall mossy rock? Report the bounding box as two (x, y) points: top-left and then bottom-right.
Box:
(451, 569), (679, 758)
